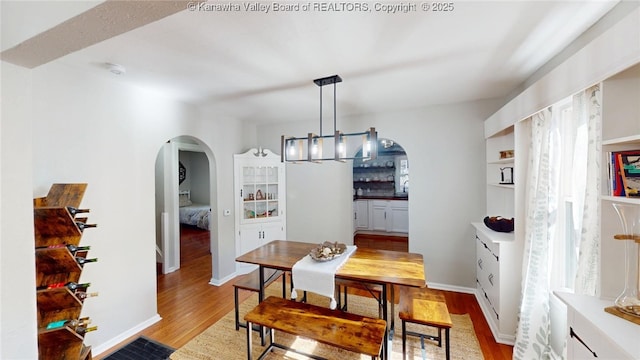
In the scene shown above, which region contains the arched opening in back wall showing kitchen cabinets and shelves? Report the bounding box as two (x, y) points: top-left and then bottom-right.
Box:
(353, 138), (409, 251)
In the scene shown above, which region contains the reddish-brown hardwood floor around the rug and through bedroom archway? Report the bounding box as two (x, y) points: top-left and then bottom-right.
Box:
(93, 227), (513, 360)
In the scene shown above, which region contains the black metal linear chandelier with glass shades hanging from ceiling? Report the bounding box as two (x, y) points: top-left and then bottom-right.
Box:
(280, 75), (378, 163)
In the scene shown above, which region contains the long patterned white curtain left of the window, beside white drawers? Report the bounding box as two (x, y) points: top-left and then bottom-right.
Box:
(513, 109), (555, 359)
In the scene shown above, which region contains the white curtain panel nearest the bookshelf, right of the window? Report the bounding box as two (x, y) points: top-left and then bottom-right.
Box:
(573, 85), (602, 296)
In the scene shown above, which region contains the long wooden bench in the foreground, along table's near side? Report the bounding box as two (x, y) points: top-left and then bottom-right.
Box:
(244, 296), (386, 360)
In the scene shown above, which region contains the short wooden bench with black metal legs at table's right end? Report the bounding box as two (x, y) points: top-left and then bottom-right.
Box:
(398, 286), (453, 360)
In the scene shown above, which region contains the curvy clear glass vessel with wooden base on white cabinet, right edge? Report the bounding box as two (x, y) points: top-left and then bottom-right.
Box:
(605, 203), (640, 324)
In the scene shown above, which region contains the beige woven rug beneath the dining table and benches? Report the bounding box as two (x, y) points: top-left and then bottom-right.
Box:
(170, 281), (483, 360)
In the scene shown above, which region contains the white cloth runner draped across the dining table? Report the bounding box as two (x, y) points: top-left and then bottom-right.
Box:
(291, 245), (356, 309)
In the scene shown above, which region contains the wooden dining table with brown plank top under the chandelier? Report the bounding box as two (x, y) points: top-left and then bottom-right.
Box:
(236, 240), (426, 359)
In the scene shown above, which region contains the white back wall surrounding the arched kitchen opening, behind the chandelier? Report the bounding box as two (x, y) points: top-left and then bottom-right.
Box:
(258, 101), (499, 288)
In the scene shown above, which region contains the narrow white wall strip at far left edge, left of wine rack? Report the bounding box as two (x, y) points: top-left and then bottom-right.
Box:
(0, 62), (38, 360)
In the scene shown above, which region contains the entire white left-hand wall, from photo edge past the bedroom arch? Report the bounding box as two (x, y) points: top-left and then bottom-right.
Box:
(0, 62), (244, 359)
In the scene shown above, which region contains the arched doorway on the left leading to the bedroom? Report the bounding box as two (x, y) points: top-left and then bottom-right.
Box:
(155, 136), (219, 278)
